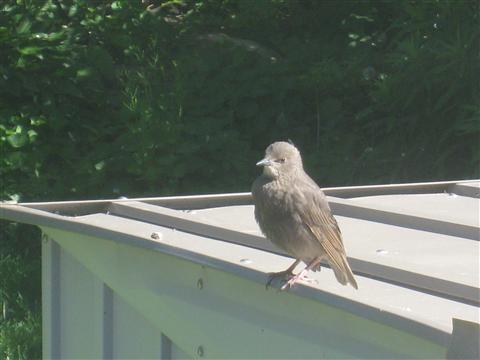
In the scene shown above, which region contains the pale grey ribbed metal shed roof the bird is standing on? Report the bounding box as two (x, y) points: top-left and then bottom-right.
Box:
(0, 180), (480, 356)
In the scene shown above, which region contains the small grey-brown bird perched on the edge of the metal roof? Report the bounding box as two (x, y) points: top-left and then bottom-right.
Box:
(252, 141), (358, 290)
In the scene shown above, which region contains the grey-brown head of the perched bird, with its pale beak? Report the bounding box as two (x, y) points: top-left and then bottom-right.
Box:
(257, 141), (303, 179)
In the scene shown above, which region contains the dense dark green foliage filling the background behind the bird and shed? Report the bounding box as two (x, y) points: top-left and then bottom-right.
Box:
(0, 0), (480, 358)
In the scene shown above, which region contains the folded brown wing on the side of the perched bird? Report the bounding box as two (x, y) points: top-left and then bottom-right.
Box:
(300, 183), (345, 268)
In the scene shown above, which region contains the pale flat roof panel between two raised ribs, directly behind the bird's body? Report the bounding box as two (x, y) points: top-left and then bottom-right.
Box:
(188, 202), (479, 286)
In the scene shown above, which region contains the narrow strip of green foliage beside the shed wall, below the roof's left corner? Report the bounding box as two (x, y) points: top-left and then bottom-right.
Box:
(0, 221), (42, 359)
